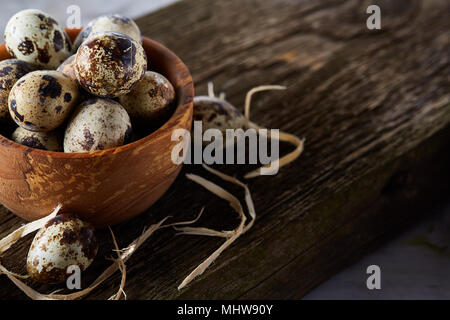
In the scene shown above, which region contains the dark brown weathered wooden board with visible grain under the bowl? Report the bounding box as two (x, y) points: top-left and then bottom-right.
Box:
(0, 0), (450, 299)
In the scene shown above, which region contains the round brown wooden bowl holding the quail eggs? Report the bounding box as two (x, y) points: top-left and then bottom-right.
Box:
(0, 29), (194, 227)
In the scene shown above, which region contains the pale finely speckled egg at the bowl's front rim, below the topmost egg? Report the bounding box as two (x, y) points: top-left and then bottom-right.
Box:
(64, 98), (132, 152)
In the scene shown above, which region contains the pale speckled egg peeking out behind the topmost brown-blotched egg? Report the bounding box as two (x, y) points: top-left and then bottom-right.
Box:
(74, 14), (142, 48)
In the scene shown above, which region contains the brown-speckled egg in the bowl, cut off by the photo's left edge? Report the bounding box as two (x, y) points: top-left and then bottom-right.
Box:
(0, 59), (34, 119)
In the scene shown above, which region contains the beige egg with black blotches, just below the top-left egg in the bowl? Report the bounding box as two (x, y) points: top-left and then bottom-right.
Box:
(8, 71), (79, 132)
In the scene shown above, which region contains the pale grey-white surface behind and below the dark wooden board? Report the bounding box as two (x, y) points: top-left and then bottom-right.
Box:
(0, 0), (450, 299)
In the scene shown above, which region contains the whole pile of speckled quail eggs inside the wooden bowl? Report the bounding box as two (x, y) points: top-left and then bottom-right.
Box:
(0, 9), (175, 152)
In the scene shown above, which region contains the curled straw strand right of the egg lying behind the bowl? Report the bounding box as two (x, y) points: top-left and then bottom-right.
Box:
(244, 85), (305, 179)
